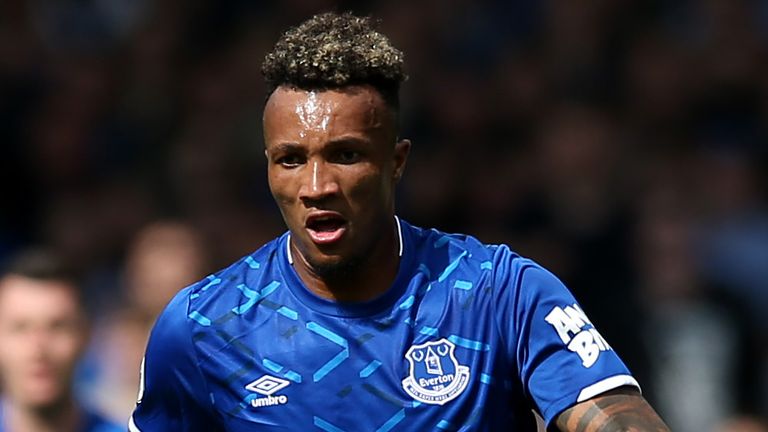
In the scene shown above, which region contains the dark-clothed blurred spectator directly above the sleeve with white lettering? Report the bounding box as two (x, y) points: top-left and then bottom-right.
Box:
(508, 103), (646, 383)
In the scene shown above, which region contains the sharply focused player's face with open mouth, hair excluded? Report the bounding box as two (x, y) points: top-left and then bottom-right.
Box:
(264, 86), (410, 275)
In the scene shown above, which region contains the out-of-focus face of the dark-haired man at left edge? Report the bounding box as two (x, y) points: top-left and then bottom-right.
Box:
(0, 275), (86, 408)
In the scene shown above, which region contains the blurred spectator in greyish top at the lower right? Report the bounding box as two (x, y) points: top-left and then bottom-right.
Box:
(636, 179), (757, 432)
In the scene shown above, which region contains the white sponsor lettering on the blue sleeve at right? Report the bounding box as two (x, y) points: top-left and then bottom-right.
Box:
(544, 304), (611, 368)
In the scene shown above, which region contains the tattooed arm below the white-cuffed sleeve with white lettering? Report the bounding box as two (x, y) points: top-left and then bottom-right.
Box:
(556, 389), (669, 432)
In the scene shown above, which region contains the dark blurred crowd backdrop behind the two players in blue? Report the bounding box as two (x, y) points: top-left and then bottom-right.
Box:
(0, 0), (768, 431)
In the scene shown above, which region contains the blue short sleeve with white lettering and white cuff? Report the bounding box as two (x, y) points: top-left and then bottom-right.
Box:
(498, 250), (639, 424)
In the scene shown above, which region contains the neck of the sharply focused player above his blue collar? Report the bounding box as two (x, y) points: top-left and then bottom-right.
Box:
(292, 218), (401, 302)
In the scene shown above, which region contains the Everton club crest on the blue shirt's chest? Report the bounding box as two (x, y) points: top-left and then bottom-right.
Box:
(403, 339), (469, 405)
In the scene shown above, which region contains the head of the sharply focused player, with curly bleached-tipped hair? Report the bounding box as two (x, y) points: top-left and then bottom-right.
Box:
(263, 14), (410, 277)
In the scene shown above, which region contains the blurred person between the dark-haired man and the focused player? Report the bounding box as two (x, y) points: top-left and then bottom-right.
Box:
(83, 220), (207, 423)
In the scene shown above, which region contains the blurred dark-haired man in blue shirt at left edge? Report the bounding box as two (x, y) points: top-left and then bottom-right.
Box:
(0, 250), (123, 432)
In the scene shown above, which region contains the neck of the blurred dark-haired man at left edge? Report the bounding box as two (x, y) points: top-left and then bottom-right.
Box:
(3, 397), (80, 432)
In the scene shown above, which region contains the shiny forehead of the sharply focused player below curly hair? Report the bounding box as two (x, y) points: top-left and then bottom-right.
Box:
(264, 86), (394, 142)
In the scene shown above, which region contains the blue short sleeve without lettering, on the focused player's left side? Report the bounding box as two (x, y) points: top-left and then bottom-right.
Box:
(128, 288), (219, 432)
